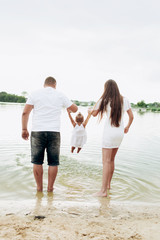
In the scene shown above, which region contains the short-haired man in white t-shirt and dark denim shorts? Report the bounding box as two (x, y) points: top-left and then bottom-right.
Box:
(22, 77), (78, 192)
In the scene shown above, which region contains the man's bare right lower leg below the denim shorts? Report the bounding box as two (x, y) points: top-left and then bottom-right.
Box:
(48, 166), (58, 192)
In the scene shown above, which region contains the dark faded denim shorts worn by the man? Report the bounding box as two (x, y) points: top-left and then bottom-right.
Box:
(31, 131), (60, 166)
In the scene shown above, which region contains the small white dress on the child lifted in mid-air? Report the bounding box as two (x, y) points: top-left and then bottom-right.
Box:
(71, 124), (87, 148)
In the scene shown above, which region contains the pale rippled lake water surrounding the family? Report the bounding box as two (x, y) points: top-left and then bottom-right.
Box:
(0, 103), (160, 213)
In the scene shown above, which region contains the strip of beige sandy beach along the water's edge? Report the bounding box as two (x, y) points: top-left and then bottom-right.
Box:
(0, 196), (160, 240)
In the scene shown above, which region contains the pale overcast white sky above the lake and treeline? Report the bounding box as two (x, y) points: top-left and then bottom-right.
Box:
(0, 0), (160, 103)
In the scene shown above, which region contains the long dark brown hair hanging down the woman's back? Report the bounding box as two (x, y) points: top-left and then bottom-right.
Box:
(99, 79), (123, 127)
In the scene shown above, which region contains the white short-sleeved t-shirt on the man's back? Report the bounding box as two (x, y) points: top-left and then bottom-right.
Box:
(26, 87), (73, 132)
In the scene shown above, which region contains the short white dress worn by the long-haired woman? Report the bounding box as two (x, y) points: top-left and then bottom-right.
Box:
(95, 97), (131, 148)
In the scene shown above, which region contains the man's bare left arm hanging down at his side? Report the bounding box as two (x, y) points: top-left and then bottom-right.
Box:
(22, 104), (33, 140)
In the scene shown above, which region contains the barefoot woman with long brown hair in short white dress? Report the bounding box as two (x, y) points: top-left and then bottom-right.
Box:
(91, 80), (133, 197)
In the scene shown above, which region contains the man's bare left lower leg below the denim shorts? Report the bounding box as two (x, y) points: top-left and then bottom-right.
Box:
(33, 164), (43, 192)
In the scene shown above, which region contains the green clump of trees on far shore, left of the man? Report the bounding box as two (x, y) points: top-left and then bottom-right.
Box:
(0, 92), (26, 103)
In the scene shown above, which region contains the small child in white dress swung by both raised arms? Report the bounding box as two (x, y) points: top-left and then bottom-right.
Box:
(67, 110), (91, 153)
